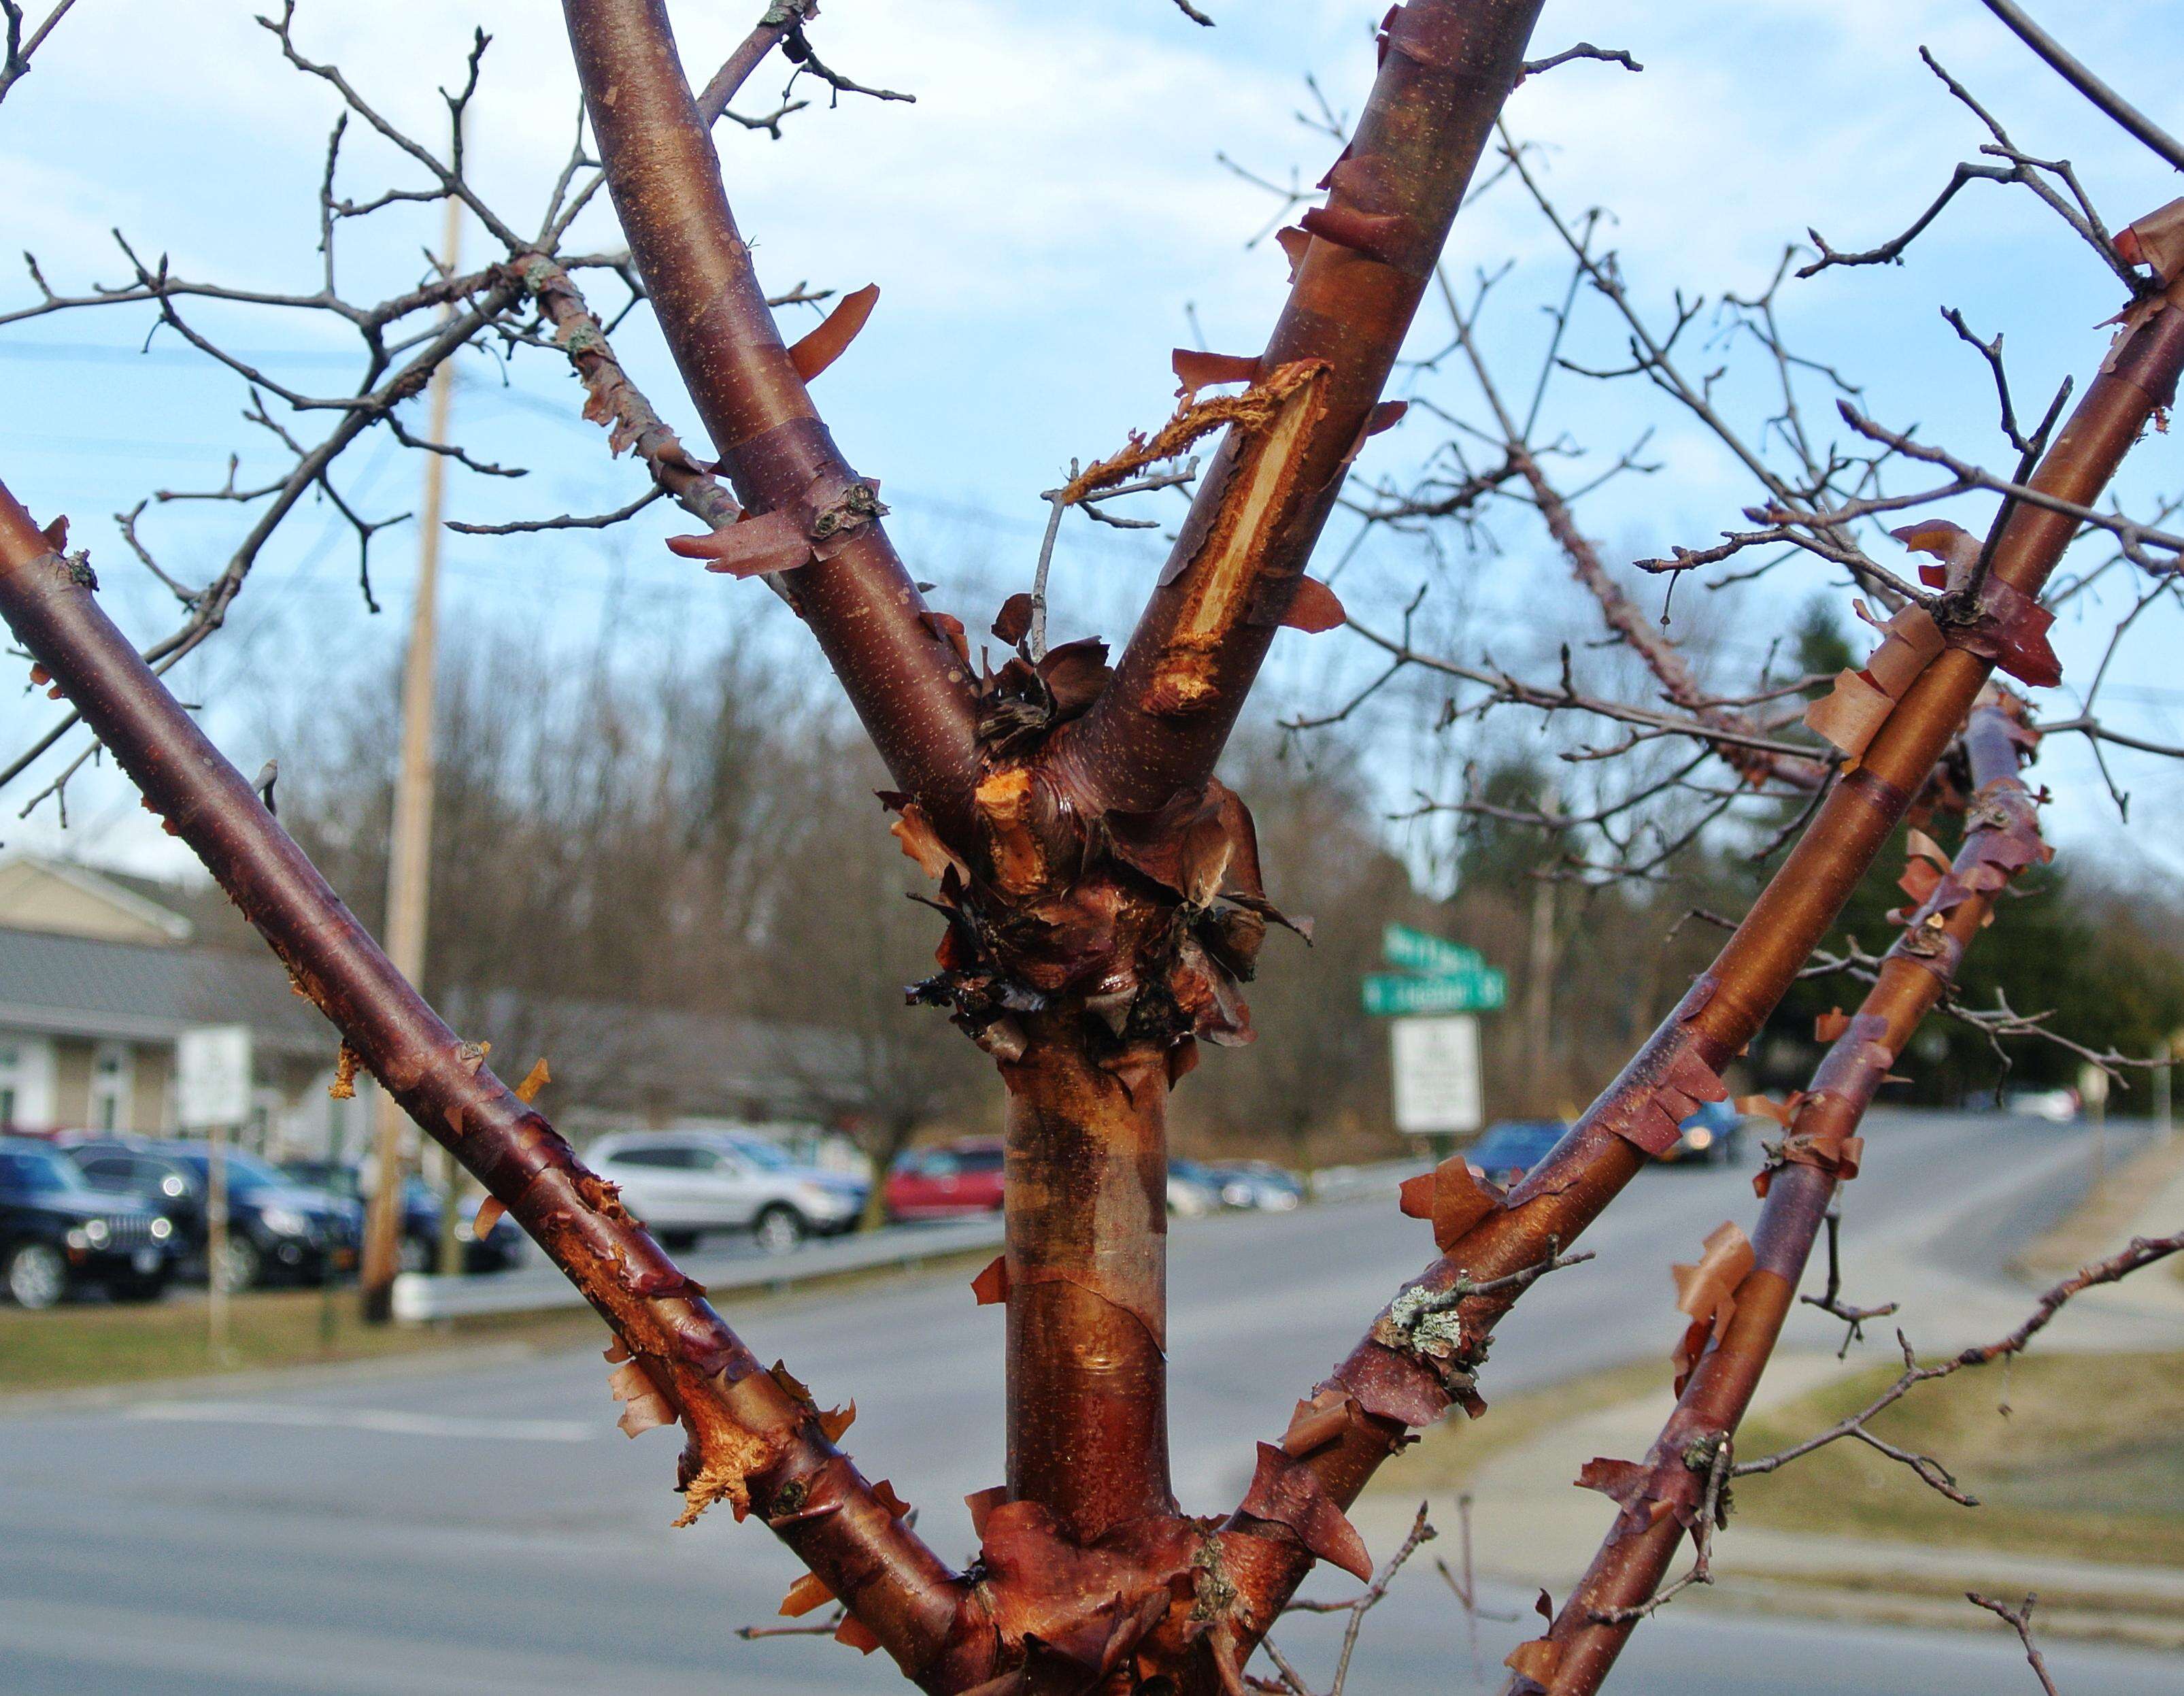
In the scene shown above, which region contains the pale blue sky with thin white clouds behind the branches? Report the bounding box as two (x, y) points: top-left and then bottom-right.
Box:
(0, 0), (2184, 887)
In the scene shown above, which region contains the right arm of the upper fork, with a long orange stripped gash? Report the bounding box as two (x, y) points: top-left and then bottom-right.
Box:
(1057, 0), (1542, 811)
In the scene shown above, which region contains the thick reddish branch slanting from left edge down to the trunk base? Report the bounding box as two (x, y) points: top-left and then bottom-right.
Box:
(0, 485), (967, 1687)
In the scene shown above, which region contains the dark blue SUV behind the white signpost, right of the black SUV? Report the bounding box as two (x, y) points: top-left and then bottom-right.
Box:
(68, 1139), (365, 1292)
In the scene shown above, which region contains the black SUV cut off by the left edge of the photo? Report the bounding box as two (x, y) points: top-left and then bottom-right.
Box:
(0, 1137), (177, 1307)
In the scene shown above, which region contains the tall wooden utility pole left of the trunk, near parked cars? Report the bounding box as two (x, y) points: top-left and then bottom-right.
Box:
(360, 195), (463, 1325)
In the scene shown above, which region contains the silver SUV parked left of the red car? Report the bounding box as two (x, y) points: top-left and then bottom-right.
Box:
(588, 1130), (869, 1254)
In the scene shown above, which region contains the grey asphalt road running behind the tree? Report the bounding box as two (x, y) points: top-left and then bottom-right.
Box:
(0, 1114), (2177, 1696)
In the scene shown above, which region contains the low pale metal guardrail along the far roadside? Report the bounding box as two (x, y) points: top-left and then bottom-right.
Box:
(393, 1161), (1419, 1325)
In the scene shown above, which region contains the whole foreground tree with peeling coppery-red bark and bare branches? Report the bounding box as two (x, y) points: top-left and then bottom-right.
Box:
(0, 0), (2184, 1696)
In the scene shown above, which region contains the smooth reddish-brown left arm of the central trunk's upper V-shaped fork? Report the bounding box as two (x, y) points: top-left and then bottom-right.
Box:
(563, 0), (974, 839)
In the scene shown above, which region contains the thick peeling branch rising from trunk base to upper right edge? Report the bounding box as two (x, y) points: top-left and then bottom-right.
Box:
(1188, 264), (2184, 1669)
